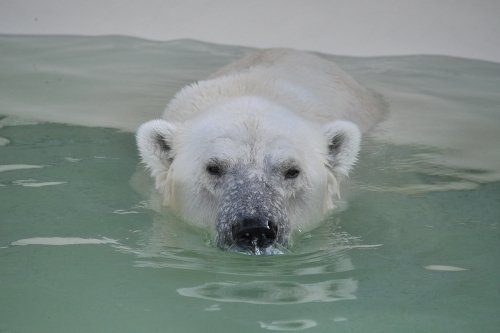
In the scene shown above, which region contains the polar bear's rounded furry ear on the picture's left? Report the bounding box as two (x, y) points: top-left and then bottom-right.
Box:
(136, 119), (176, 176)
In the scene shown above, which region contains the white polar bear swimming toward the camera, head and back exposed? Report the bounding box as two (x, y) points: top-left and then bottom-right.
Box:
(137, 49), (384, 254)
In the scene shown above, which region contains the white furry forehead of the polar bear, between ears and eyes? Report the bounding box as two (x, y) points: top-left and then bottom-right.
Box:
(179, 107), (324, 160)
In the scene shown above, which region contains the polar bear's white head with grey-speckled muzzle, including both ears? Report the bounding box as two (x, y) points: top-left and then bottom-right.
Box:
(137, 97), (361, 253)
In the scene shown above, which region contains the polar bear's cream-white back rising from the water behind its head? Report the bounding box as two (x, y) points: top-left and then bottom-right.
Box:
(163, 49), (384, 131)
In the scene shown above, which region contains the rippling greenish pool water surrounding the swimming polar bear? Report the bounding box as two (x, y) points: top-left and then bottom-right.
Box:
(0, 36), (500, 332)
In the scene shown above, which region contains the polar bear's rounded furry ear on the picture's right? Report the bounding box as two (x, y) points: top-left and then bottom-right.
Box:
(324, 121), (361, 176)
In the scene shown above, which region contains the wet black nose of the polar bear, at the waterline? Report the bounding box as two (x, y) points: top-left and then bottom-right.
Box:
(232, 218), (278, 249)
